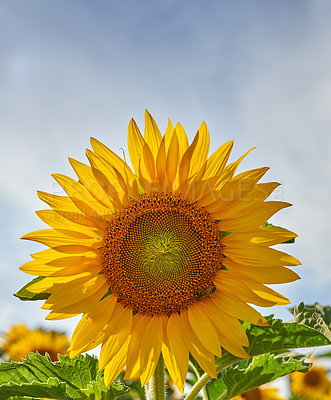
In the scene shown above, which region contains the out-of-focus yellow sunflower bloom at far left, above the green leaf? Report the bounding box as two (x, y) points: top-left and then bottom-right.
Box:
(2, 324), (69, 361)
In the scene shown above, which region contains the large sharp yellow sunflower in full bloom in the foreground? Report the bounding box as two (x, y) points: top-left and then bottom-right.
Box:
(21, 111), (300, 391)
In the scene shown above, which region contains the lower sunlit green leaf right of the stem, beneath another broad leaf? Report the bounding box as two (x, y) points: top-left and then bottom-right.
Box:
(207, 352), (310, 400)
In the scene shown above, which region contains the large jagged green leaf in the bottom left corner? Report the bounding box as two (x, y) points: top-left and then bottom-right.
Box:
(0, 353), (128, 400)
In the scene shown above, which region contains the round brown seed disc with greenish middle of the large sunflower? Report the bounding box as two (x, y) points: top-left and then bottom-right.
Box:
(101, 193), (222, 315)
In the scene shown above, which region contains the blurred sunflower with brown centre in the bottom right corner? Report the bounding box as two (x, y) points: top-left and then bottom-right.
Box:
(290, 366), (331, 400)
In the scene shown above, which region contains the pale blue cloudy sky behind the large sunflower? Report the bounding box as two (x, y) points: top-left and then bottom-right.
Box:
(0, 0), (331, 340)
